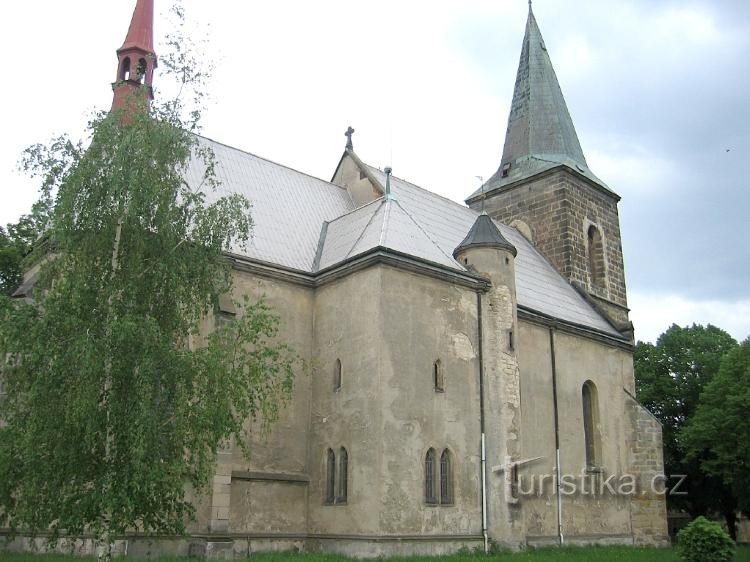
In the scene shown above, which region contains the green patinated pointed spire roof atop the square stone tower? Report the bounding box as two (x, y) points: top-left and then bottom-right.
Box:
(469, 9), (609, 199)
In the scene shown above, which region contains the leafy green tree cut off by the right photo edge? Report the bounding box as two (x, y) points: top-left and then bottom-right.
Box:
(682, 338), (750, 513)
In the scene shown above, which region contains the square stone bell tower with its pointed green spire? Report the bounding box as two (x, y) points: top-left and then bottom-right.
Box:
(466, 5), (632, 334)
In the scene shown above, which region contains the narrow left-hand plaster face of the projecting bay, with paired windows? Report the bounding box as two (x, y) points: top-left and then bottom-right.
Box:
(307, 267), (382, 535)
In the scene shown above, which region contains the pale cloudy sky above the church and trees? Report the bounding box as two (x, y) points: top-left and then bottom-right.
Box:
(0, 0), (750, 341)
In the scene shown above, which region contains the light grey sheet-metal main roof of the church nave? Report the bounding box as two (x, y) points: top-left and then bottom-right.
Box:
(186, 138), (619, 336)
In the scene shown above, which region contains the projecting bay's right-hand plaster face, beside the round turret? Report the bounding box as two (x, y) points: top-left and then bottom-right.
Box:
(379, 267), (481, 536)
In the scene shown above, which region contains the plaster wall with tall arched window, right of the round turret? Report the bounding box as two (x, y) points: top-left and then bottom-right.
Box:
(519, 321), (644, 543)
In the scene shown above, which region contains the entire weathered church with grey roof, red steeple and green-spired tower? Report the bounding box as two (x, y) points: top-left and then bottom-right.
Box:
(14, 0), (667, 557)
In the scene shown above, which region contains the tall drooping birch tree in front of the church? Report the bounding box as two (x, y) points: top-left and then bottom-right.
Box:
(0, 3), (297, 543)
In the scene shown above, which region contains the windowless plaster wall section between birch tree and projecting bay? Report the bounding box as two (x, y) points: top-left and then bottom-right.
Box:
(208, 271), (314, 534)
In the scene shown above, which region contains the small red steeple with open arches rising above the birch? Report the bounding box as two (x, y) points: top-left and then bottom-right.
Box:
(112, 0), (156, 110)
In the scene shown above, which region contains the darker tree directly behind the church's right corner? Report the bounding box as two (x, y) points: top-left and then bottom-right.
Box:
(634, 325), (737, 518)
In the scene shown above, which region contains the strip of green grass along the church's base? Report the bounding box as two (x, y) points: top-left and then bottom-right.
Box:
(0, 547), (750, 562)
